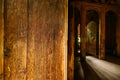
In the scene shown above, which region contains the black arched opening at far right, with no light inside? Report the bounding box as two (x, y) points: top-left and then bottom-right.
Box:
(105, 11), (117, 55)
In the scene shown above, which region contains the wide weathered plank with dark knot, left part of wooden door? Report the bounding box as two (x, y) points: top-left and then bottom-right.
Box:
(4, 0), (27, 80)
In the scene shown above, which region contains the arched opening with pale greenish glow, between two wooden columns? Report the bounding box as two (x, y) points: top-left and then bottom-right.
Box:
(86, 10), (99, 56)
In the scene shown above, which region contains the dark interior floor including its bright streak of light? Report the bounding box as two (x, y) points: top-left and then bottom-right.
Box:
(74, 56), (120, 80)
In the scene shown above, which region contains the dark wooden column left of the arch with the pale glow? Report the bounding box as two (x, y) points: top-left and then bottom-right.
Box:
(80, 8), (86, 60)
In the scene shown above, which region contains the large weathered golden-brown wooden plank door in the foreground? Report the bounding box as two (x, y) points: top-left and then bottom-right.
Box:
(4, 0), (68, 80)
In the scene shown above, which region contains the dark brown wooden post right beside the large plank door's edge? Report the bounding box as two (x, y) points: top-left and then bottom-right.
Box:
(67, 6), (75, 80)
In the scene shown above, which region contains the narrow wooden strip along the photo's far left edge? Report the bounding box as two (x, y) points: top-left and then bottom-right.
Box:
(0, 0), (4, 80)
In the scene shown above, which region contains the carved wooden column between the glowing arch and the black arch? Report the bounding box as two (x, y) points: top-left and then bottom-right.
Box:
(99, 10), (105, 59)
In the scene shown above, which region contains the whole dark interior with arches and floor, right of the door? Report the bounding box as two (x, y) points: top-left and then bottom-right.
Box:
(68, 0), (120, 80)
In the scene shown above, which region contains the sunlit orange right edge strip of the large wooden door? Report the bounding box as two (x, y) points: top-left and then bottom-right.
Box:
(62, 0), (68, 80)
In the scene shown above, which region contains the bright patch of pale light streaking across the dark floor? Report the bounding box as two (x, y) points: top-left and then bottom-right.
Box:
(86, 56), (120, 80)
